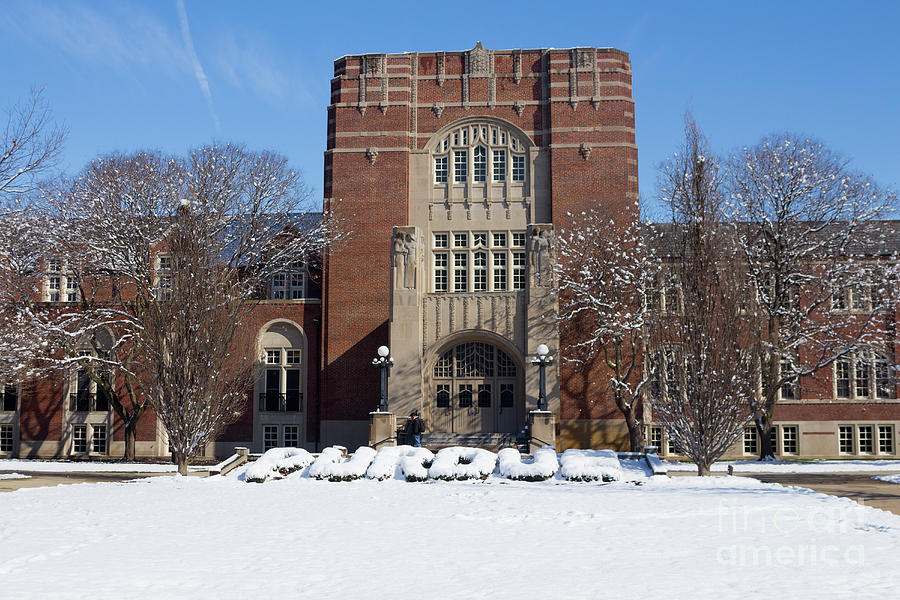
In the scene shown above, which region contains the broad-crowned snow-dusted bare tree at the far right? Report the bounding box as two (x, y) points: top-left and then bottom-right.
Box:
(730, 134), (897, 459)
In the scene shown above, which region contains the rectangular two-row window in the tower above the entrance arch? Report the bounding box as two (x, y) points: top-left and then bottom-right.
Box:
(432, 231), (527, 293)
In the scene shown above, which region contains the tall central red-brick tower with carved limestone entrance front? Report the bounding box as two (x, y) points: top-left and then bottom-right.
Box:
(320, 43), (638, 445)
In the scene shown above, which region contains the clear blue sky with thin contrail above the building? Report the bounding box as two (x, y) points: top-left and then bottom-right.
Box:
(0, 0), (900, 216)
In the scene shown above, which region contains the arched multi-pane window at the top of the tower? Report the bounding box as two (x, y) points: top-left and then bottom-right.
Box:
(433, 123), (527, 185)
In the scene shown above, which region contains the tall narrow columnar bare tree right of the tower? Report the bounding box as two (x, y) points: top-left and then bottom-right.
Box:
(649, 118), (754, 475)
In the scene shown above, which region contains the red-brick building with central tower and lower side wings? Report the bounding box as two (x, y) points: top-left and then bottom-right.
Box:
(0, 43), (900, 457)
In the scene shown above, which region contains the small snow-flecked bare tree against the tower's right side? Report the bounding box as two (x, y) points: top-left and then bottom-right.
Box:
(557, 203), (658, 452)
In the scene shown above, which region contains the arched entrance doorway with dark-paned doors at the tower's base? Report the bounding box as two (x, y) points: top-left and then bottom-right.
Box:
(426, 341), (525, 433)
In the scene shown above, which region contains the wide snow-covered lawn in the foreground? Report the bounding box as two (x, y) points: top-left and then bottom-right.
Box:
(0, 472), (900, 600)
